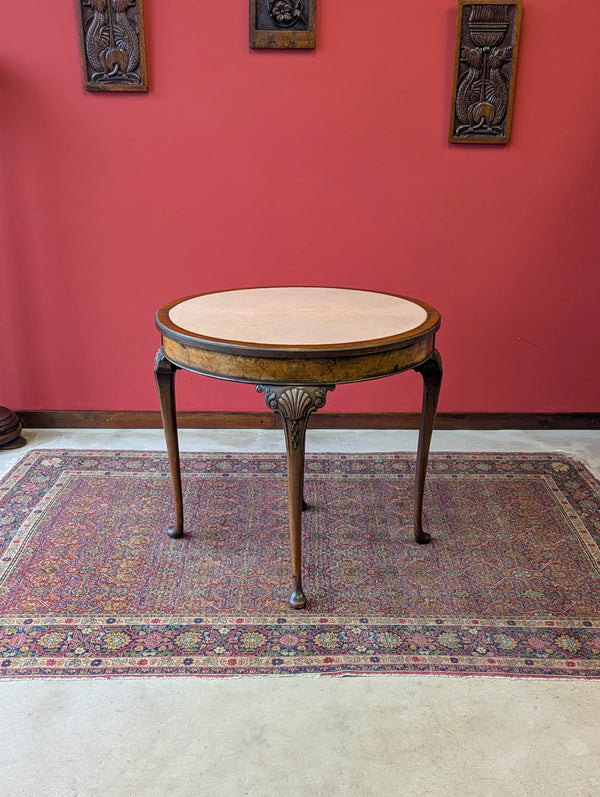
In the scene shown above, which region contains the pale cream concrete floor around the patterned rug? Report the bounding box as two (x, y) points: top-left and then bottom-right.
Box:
(0, 430), (600, 797)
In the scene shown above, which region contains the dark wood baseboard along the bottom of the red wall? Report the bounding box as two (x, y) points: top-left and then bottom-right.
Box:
(18, 410), (600, 430)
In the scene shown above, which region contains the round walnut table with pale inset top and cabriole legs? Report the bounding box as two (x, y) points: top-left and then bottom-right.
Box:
(155, 288), (442, 609)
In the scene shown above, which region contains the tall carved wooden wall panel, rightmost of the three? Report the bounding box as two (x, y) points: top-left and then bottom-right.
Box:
(449, 0), (522, 144)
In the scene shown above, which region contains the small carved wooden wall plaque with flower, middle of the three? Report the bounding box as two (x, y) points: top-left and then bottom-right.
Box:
(250, 0), (317, 50)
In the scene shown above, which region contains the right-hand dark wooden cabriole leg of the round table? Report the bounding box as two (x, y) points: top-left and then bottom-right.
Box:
(414, 349), (443, 544)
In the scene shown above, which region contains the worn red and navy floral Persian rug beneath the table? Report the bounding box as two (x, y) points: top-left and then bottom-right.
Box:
(0, 450), (600, 678)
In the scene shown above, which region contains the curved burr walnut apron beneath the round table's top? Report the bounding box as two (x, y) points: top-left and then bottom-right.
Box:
(162, 333), (435, 385)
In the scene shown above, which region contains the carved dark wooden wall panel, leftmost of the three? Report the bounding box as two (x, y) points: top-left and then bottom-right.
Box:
(77, 0), (148, 91)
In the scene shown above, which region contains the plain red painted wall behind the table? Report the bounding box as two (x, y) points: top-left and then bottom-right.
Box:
(0, 0), (600, 412)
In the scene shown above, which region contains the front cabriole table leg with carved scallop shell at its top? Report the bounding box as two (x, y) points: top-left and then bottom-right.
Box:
(256, 385), (334, 609)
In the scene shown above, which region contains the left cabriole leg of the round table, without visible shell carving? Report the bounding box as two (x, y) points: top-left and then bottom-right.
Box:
(154, 347), (183, 538)
